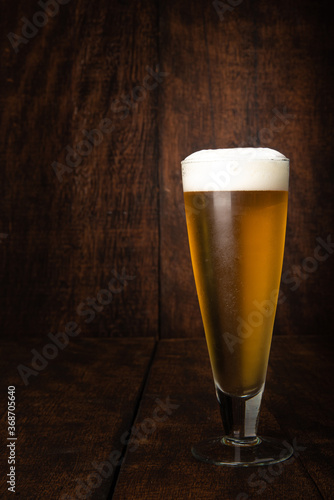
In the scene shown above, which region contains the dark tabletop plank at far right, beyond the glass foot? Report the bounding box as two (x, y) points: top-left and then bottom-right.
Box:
(267, 335), (334, 498)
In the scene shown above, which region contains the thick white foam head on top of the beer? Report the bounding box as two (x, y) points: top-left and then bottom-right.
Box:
(181, 148), (289, 191)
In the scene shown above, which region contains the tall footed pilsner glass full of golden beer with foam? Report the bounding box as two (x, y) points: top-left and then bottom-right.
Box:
(182, 148), (293, 466)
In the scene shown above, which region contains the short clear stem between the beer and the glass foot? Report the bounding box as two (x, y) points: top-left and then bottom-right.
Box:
(216, 386), (264, 446)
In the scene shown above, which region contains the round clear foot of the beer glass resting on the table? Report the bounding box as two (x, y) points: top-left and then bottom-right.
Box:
(191, 437), (293, 467)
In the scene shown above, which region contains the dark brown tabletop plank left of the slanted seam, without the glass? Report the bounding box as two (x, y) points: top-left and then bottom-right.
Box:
(0, 339), (154, 499)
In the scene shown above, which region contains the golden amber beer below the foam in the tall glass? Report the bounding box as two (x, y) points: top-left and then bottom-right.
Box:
(184, 191), (288, 396)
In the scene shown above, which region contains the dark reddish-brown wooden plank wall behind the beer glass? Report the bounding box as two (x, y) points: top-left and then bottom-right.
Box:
(0, 0), (334, 338)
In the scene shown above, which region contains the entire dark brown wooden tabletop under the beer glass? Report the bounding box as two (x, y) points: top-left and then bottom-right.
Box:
(0, 336), (334, 500)
